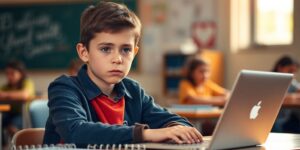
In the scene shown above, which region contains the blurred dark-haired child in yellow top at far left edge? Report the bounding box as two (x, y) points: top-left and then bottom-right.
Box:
(0, 61), (35, 144)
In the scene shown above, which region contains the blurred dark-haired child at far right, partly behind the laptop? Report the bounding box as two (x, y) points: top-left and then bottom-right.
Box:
(272, 56), (300, 133)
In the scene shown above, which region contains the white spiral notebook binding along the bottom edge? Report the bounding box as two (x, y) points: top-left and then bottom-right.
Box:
(11, 144), (146, 150)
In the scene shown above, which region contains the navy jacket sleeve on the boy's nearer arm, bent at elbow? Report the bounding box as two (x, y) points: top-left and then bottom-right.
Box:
(48, 78), (134, 145)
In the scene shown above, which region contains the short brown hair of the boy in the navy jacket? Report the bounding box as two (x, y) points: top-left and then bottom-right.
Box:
(80, 2), (141, 49)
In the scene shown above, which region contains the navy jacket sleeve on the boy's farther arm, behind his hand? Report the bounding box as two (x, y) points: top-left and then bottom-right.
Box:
(140, 85), (193, 128)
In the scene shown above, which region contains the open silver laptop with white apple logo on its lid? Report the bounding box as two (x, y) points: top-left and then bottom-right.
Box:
(145, 70), (293, 149)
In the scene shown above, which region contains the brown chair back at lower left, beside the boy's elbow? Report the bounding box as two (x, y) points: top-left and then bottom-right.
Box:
(11, 128), (45, 148)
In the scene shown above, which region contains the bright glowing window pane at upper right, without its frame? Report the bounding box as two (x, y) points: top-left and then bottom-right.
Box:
(253, 0), (294, 45)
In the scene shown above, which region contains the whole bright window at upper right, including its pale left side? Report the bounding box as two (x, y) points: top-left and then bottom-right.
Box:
(230, 0), (297, 52)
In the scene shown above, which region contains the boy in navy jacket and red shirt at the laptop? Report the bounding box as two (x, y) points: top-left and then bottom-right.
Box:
(44, 2), (202, 147)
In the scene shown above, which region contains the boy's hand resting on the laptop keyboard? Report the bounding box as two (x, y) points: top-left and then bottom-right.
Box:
(143, 125), (203, 144)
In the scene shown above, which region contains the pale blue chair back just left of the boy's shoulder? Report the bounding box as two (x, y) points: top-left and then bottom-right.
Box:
(29, 100), (49, 128)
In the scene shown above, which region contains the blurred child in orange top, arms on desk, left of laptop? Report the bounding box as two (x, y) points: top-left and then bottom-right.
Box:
(179, 57), (228, 105)
